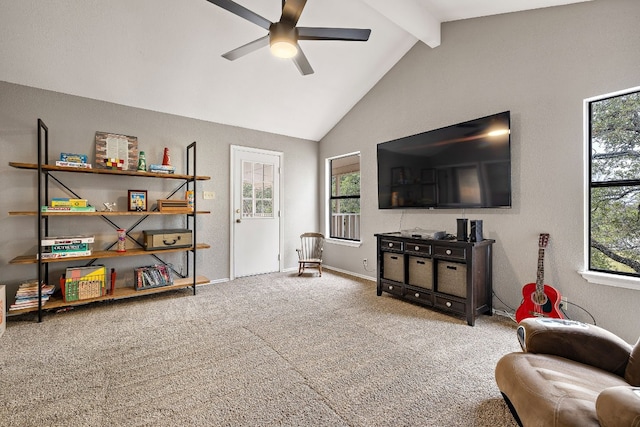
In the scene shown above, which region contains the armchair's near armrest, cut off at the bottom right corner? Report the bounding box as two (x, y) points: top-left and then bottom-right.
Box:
(596, 386), (640, 426)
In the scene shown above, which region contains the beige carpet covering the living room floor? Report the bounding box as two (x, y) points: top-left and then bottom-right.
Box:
(0, 271), (518, 427)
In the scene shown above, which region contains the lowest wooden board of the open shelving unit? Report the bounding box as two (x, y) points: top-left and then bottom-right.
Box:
(7, 276), (210, 316)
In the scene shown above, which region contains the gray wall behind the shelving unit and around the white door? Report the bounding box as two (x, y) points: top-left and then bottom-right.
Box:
(0, 82), (319, 301)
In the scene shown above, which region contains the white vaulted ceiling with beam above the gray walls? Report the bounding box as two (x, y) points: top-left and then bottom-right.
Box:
(0, 0), (588, 141)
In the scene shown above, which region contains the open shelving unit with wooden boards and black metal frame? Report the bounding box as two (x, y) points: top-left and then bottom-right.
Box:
(8, 119), (210, 321)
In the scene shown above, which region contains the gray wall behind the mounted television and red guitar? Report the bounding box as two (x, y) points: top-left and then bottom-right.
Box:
(320, 0), (640, 342)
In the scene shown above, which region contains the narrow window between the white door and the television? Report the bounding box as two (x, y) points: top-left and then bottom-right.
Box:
(327, 153), (360, 241)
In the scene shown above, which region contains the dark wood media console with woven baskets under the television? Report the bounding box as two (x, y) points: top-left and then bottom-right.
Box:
(375, 233), (495, 326)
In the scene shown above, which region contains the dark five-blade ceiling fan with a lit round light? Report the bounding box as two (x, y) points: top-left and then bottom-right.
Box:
(207, 0), (371, 75)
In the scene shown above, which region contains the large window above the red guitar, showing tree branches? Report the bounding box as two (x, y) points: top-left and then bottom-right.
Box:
(585, 88), (640, 277)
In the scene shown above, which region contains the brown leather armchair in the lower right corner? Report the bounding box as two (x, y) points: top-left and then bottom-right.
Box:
(495, 318), (640, 427)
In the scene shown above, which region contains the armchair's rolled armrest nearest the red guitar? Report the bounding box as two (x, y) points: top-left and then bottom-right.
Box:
(518, 317), (632, 377)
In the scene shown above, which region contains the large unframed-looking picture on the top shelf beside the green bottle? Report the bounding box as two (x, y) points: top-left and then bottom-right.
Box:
(96, 132), (138, 171)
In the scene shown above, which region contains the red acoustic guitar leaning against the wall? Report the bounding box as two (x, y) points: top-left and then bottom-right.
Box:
(516, 233), (564, 323)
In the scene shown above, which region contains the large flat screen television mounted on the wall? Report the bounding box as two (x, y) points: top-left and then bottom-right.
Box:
(378, 111), (511, 209)
